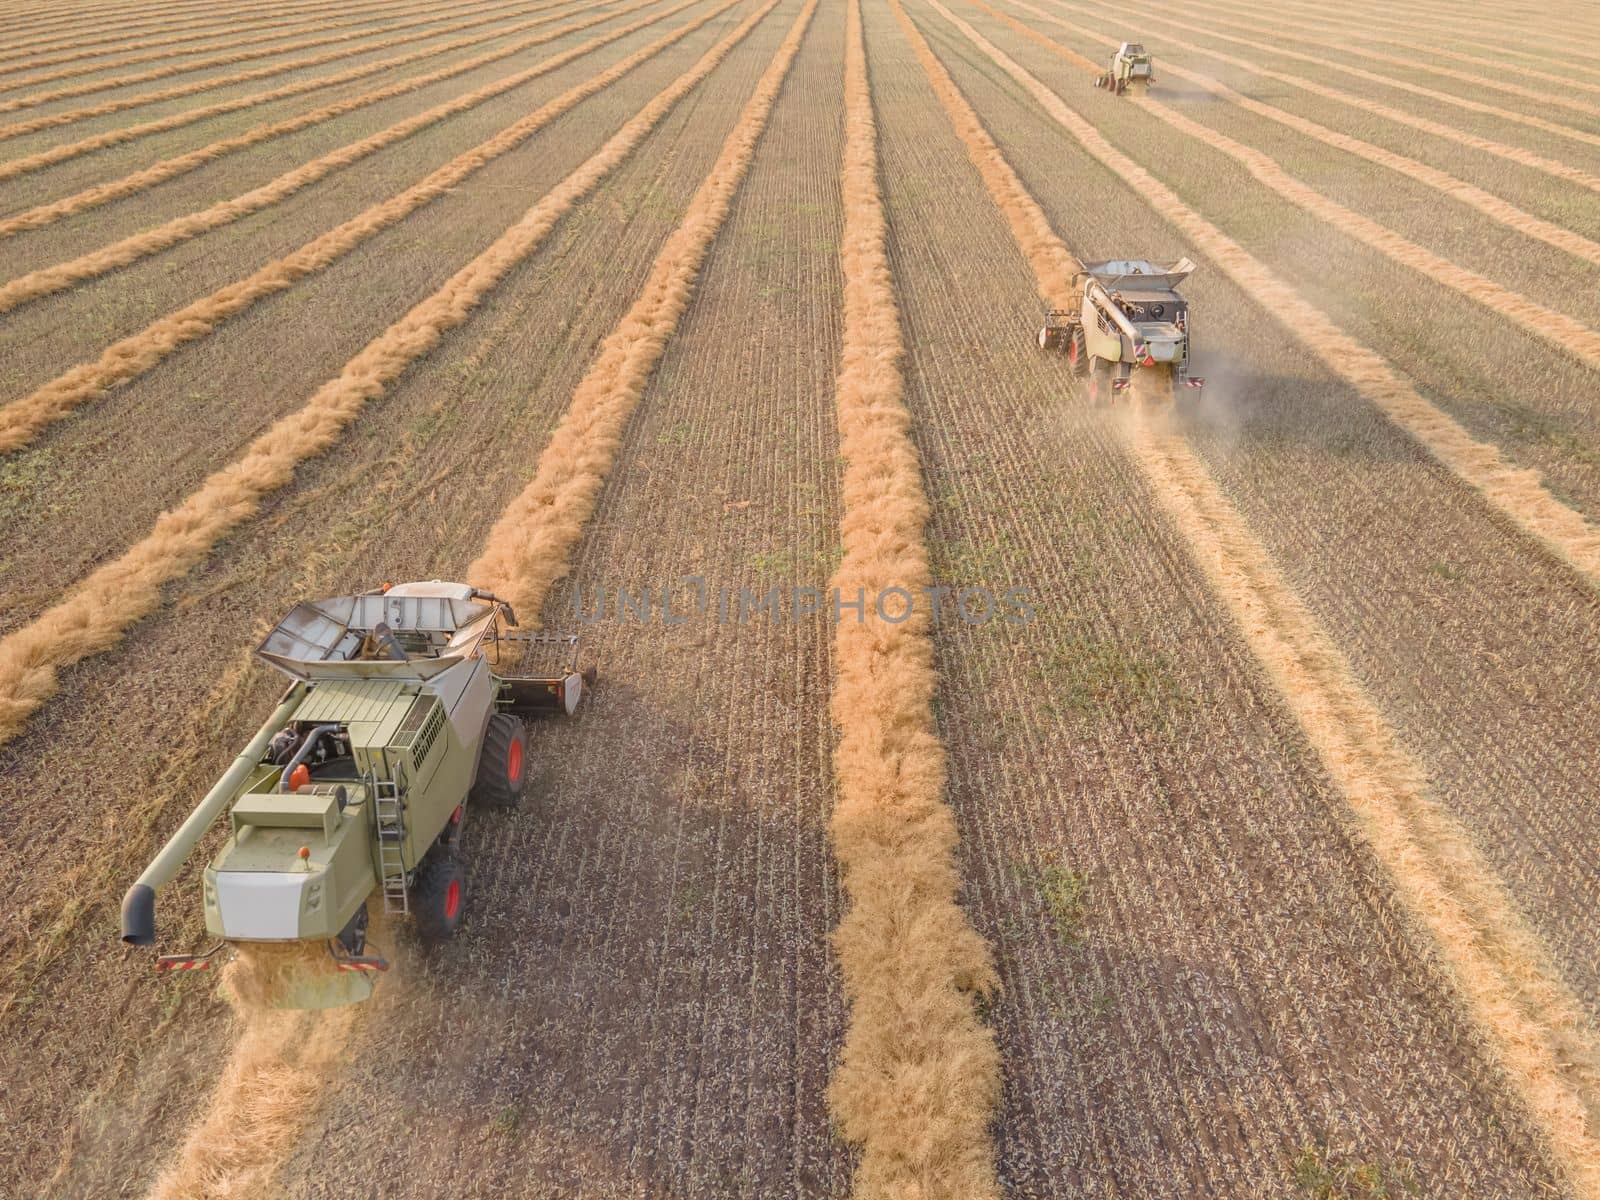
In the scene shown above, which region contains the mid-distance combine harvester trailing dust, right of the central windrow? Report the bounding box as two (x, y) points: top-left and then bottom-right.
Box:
(1038, 259), (1205, 402)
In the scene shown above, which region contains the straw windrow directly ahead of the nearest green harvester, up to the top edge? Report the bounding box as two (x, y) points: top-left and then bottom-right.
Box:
(467, 0), (816, 613)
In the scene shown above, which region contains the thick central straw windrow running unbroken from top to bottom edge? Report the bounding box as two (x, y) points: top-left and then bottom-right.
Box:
(829, 0), (1000, 1200)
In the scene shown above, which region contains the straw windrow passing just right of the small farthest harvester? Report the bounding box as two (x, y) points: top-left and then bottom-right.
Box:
(992, 0), (1600, 266)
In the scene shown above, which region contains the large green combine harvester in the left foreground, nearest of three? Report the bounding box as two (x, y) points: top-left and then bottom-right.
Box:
(122, 579), (594, 1008)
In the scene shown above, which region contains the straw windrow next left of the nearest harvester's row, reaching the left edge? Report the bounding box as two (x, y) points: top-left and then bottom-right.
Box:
(0, 0), (777, 744)
